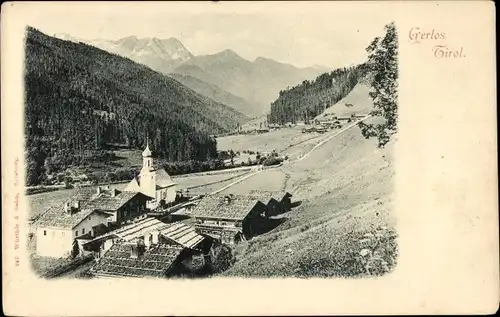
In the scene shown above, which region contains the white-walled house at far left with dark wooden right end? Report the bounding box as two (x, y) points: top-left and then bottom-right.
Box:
(34, 187), (148, 257)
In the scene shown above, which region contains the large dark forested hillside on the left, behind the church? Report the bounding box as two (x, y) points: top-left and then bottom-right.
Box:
(25, 28), (247, 185)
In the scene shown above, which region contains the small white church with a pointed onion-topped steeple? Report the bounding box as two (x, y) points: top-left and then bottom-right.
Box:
(125, 142), (177, 209)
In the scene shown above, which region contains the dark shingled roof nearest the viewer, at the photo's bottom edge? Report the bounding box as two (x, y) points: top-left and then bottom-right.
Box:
(92, 242), (183, 277)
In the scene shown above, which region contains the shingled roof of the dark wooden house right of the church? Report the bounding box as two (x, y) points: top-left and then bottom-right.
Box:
(191, 195), (262, 220)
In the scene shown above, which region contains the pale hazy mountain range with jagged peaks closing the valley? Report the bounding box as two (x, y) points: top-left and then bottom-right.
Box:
(56, 34), (329, 117)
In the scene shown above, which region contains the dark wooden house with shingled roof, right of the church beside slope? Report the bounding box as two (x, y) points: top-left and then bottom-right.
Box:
(191, 195), (266, 244)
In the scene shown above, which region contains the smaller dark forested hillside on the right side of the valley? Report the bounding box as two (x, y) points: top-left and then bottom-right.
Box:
(268, 64), (366, 124)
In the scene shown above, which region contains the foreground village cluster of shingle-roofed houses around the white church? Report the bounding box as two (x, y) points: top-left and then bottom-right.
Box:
(31, 144), (293, 278)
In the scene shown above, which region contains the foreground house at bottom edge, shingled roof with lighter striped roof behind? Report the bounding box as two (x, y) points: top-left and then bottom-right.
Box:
(88, 218), (208, 277)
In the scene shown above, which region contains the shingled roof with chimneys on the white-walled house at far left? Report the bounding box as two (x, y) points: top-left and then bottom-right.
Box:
(35, 188), (146, 229)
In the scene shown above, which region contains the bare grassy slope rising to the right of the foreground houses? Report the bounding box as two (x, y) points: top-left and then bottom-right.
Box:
(225, 127), (395, 276)
